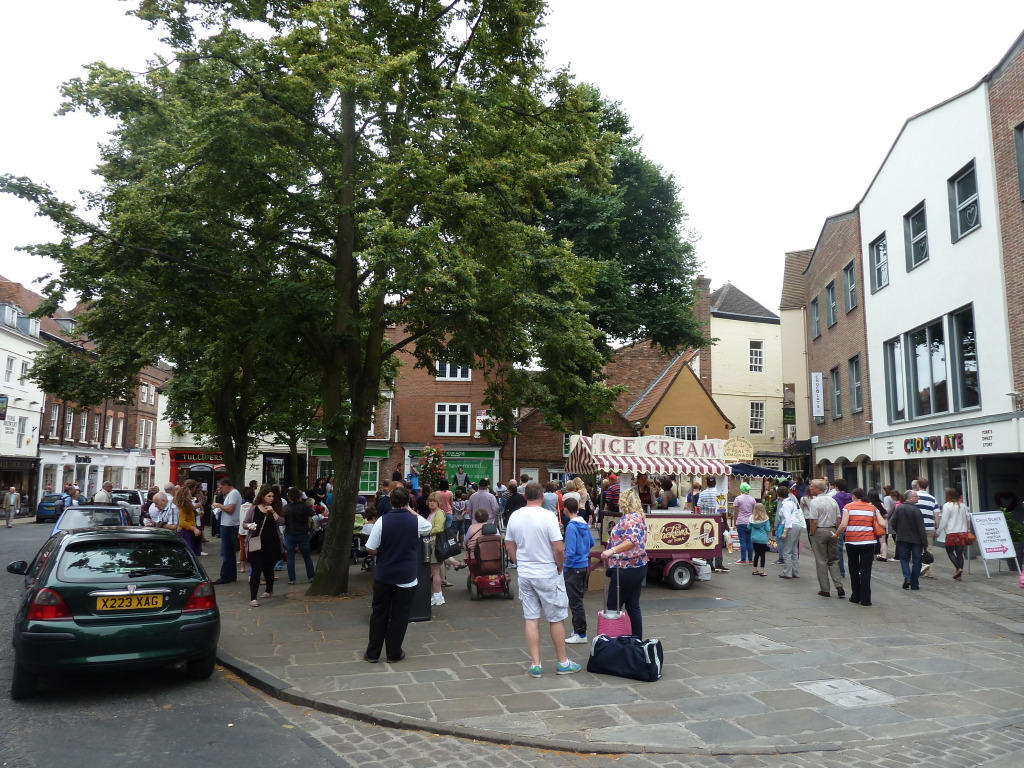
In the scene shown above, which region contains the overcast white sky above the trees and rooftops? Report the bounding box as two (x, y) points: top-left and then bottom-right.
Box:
(0, 0), (1024, 311)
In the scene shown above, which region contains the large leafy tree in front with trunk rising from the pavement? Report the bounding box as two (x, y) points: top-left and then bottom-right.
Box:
(4, 0), (610, 594)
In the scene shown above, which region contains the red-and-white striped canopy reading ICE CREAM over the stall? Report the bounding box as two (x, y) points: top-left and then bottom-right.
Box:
(565, 434), (733, 476)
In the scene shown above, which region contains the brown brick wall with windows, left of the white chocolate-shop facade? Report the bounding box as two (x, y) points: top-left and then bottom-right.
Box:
(804, 211), (871, 448)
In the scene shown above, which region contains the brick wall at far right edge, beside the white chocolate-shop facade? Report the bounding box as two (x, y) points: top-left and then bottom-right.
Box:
(988, 36), (1024, 392)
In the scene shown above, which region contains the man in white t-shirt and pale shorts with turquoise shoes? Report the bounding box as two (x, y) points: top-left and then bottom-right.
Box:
(505, 481), (580, 677)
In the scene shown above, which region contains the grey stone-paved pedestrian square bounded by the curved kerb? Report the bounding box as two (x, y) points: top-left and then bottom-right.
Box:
(218, 540), (1024, 757)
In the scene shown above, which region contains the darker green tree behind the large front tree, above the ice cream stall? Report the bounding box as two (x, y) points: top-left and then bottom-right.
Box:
(534, 89), (709, 431)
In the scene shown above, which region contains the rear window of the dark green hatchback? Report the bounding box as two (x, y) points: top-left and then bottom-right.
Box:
(57, 540), (196, 582)
